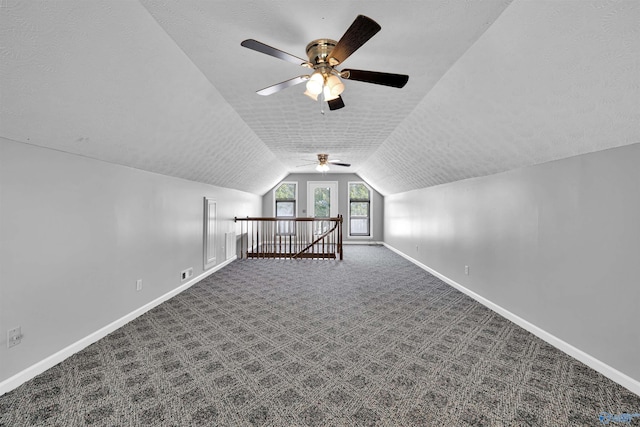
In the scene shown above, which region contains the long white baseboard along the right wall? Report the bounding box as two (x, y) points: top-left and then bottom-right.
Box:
(383, 243), (640, 395)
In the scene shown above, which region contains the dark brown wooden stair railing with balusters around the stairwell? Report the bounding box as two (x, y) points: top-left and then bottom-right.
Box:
(235, 215), (343, 260)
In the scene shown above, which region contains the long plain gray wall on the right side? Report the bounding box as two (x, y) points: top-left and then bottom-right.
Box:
(384, 144), (640, 381)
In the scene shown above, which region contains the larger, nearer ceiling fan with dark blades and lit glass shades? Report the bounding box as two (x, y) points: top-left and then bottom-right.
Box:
(241, 15), (409, 110)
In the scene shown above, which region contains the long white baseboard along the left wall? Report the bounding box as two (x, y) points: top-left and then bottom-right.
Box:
(0, 255), (237, 396)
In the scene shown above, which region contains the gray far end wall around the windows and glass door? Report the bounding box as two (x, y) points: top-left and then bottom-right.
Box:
(262, 173), (384, 242)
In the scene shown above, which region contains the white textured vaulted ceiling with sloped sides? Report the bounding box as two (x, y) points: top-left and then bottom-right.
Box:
(0, 0), (640, 194)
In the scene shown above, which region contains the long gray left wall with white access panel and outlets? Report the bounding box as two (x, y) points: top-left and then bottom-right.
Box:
(0, 138), (262, 382)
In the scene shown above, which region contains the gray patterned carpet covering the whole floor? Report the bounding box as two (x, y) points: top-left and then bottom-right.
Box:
(0, 246), (640, 426)
